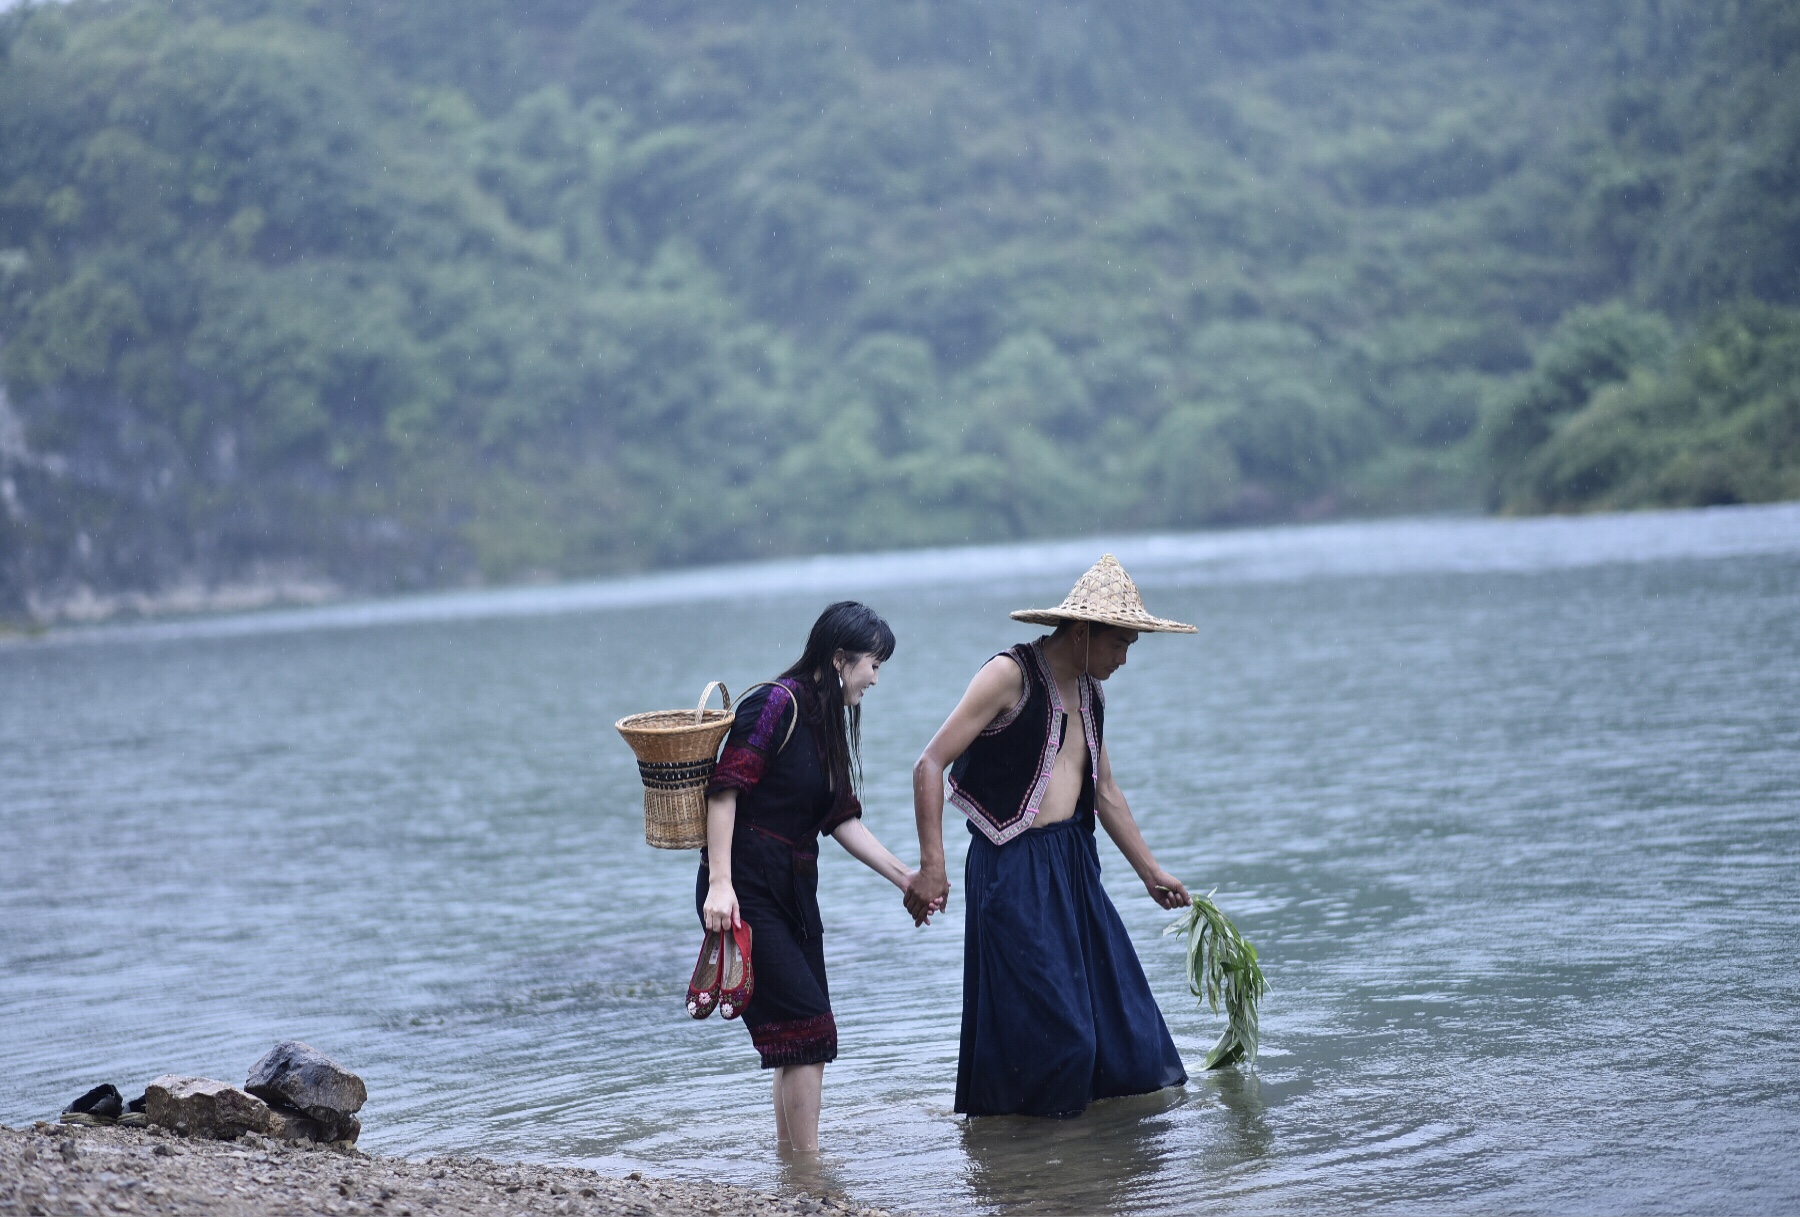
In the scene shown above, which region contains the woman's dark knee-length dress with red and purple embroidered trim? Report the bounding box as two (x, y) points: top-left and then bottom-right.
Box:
(695, 681), (862, 1069)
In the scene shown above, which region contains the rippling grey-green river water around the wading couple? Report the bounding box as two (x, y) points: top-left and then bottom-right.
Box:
(0, 506), (1800, 1213)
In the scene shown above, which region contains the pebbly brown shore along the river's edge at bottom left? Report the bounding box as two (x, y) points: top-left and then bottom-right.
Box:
(0, 1123), (887, 1217)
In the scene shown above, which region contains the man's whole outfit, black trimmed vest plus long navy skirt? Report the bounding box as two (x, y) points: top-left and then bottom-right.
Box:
(952, 639), (1188, 1116)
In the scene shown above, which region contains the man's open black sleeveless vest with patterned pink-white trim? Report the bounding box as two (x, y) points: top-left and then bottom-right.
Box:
(950, 639), (1105, 844)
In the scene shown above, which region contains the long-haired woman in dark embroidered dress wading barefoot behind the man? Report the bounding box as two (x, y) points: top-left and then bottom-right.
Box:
(695, 599), (914, 1152)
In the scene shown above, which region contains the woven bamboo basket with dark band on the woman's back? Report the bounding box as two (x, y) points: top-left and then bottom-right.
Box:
(614, 681), (736, 850)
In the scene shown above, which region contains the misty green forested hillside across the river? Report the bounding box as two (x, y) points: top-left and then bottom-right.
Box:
(0, 0), (1800, 614)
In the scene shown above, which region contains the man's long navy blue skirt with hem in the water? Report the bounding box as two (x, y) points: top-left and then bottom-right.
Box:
(956, 817), (1188, 1116)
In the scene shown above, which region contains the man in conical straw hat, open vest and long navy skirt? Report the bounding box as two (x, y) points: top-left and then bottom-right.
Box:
(905, 554), (1195, 1116)
